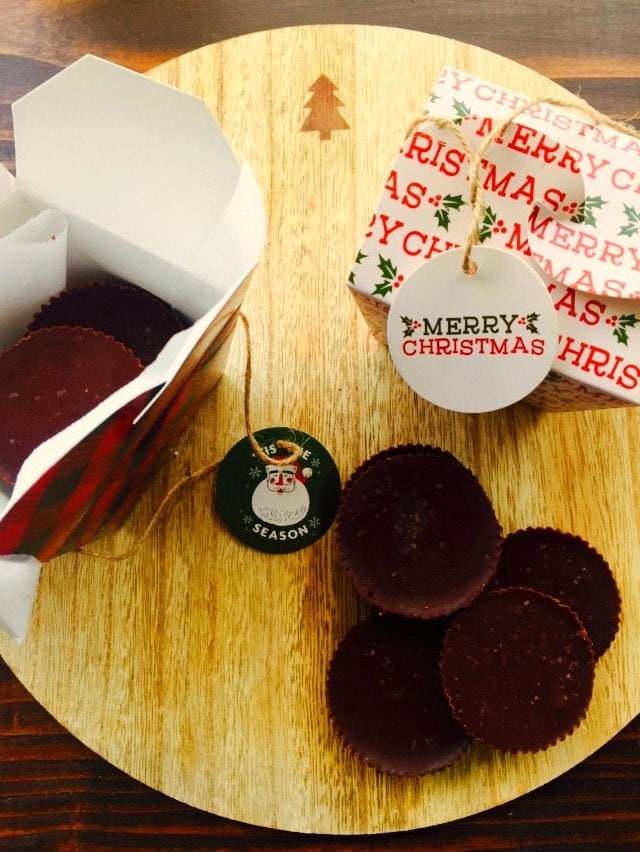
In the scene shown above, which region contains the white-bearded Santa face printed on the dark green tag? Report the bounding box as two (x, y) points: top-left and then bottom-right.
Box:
(251, 464), (311, 527)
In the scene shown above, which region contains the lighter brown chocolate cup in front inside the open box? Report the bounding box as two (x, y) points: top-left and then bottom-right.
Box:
(0, 326), (143, 485)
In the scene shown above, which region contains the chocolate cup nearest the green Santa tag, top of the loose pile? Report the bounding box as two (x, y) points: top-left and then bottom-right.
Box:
(336, 445), (502, 619)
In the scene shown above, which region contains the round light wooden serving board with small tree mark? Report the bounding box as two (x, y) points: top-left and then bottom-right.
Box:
(0, 26), (640, 834)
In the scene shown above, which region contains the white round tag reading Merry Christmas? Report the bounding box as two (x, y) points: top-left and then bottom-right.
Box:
(387, 245), (558, 413)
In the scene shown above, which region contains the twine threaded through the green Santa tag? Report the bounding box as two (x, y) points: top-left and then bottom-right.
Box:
(76, 312), (303, 562)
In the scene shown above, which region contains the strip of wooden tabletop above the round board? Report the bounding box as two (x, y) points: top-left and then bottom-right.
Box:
(0, 0), (640, 178)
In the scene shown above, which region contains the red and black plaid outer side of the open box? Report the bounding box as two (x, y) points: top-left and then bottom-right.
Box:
(0, 279), (248, 562)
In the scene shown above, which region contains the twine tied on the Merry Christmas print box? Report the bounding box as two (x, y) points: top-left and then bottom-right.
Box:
(406, 96), (640, 275)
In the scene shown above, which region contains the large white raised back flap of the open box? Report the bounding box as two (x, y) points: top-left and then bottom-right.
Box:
(12, 56), (240, 268)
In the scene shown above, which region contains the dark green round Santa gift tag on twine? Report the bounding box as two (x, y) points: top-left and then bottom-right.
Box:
(215, 426), (341, 553)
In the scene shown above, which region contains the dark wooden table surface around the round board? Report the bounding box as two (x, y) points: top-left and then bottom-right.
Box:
(0, 0), (640, 850)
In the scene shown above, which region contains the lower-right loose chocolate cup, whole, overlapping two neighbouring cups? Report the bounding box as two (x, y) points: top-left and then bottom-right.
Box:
(440, 588), (595, 752)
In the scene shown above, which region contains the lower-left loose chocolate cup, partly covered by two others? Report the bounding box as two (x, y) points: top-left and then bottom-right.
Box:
(327, 614), (471, 776)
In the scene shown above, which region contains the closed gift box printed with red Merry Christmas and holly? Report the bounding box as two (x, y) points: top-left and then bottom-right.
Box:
(349, 67), (640, 410)
